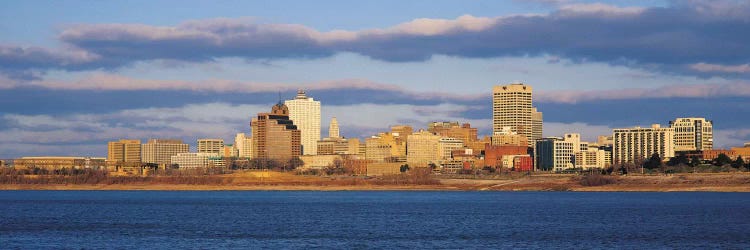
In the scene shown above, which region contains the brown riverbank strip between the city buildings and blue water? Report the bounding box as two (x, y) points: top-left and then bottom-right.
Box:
(0, 172), (750, 192)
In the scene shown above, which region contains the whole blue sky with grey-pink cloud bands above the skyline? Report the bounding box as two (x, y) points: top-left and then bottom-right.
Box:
(0, 0), (750, 158)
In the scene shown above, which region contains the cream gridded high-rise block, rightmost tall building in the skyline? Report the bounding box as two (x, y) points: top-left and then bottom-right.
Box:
(669, 117), (714, 151)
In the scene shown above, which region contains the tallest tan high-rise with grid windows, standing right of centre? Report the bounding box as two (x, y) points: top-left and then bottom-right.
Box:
(492, 83), (534, 142)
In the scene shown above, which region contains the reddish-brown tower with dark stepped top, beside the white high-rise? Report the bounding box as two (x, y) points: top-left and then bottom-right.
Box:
(250, 102), (302, 161)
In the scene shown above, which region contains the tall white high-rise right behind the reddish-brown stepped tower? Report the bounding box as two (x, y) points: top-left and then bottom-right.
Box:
(284, 89), (320, 155)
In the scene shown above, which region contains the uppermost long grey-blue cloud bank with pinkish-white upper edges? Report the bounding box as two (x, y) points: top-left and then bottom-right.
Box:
(0, 1), (750, 77)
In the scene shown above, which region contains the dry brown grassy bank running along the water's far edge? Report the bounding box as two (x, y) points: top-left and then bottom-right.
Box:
(0, 171), (750, 192)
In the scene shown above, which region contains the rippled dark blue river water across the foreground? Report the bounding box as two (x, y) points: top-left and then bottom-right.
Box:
(0, 191), (750, 249)
